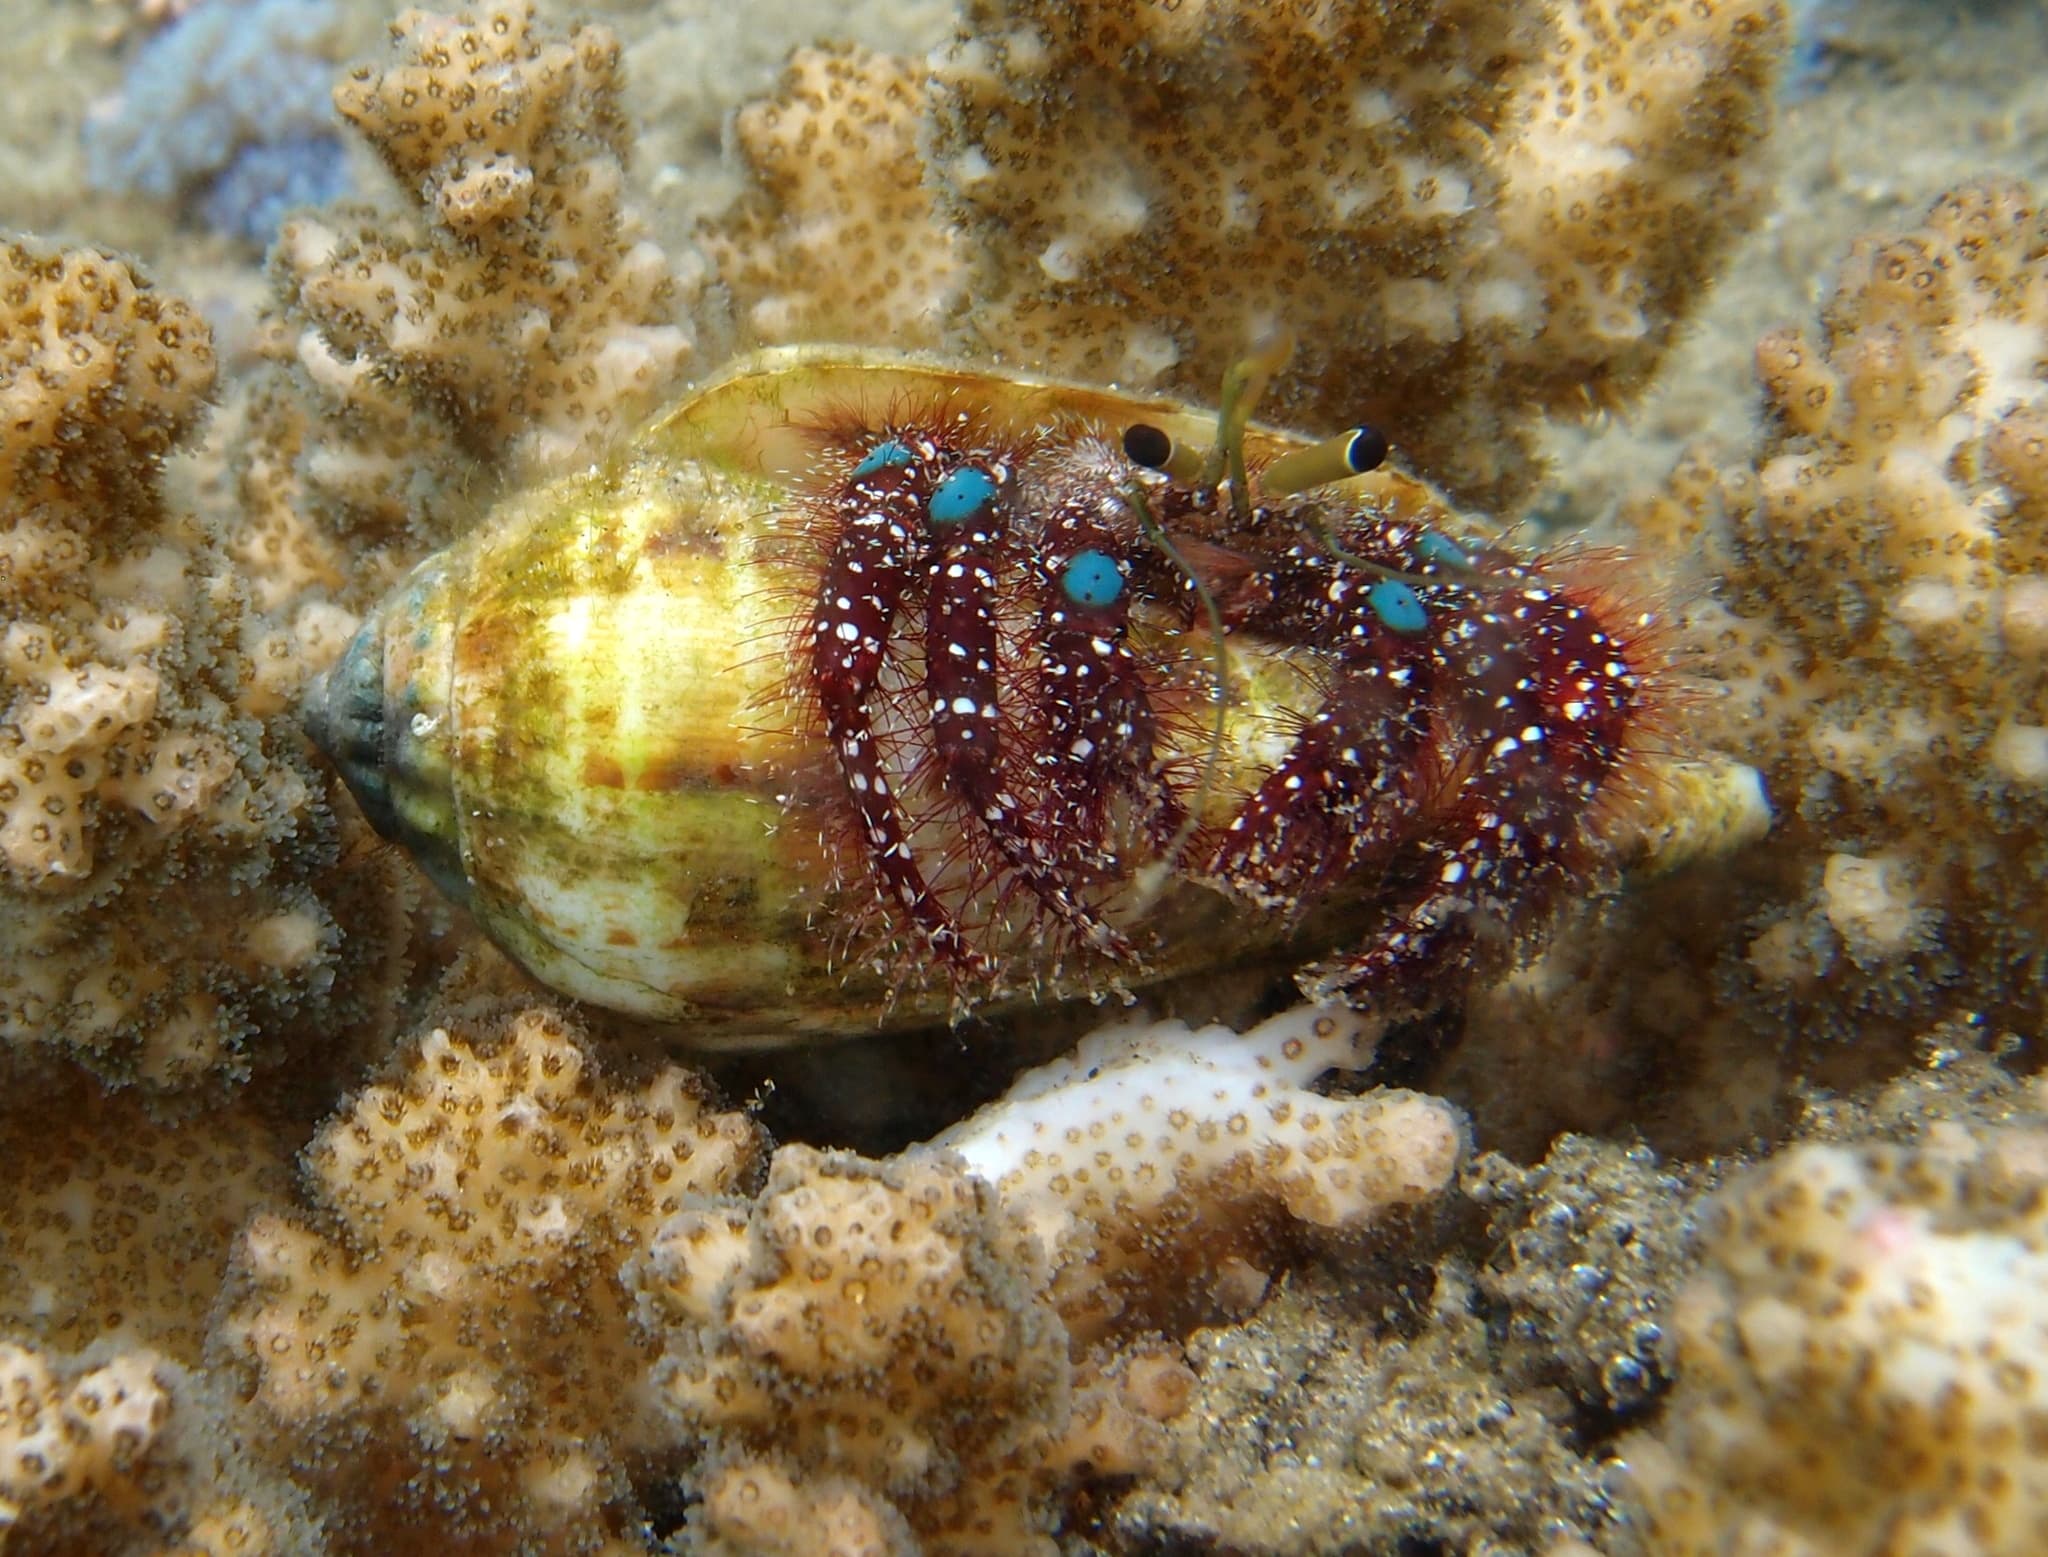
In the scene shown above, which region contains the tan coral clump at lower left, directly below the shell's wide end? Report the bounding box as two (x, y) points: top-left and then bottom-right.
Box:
(219, 1010), (760, 1549)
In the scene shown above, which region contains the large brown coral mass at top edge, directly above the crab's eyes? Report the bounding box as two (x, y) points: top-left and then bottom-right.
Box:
(709, 0), (1786, 504)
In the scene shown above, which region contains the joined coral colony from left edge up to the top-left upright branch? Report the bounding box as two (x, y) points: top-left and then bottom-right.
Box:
(0, 6), (712, 1082)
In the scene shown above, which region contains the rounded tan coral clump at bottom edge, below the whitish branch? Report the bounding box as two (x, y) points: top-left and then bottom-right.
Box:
(637, 1147), (1180, 1557)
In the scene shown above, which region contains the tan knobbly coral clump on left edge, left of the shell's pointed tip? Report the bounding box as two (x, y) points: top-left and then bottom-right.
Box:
(0, 244), (407, 1082)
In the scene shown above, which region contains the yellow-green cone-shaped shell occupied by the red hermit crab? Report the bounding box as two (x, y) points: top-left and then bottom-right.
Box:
(307, 350), (1613, 1047)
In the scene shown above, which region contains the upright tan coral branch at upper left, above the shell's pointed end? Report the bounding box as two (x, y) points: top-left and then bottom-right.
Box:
(246, 0), (690, 561)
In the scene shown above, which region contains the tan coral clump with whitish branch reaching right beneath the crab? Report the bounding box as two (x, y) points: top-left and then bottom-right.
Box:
(635, 1008), (1460, 1553)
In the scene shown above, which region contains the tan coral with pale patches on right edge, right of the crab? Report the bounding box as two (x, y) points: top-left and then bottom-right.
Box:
(1634, 182), (2048, 1022)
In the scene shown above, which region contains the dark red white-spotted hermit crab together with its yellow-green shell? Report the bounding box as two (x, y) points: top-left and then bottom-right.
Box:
(303, 348), (1728, 1047)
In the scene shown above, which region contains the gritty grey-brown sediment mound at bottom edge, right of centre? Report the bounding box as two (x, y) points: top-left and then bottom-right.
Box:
(1102, 1260), (1636, 1557)
